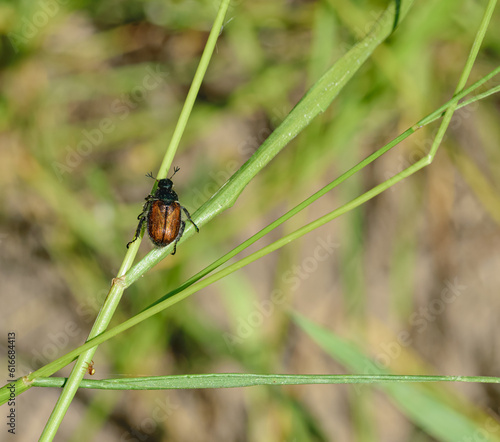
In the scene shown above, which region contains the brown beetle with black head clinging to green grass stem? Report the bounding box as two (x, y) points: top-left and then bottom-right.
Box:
(127, 167), (200, 255)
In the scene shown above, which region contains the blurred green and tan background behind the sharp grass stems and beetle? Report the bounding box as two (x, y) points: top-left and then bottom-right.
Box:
(0, 0), (500, 441)
